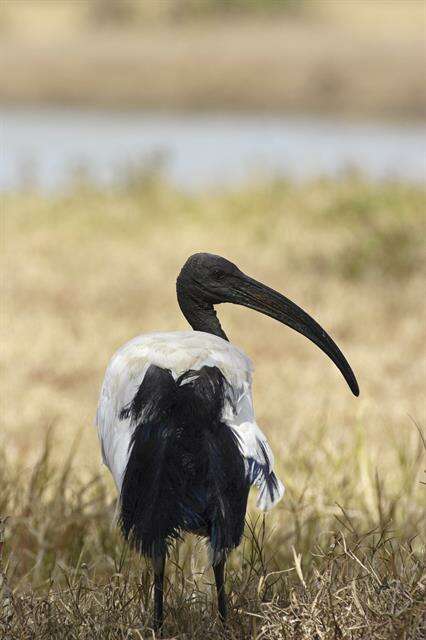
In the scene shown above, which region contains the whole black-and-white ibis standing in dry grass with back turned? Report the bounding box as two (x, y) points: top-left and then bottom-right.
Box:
(95, 253), (359, 631)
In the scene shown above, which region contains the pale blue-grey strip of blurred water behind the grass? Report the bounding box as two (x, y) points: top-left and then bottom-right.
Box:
(0, 108), (426, 190)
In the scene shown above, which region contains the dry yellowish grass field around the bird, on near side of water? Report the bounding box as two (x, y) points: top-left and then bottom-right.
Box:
(0, 174), (426, 640)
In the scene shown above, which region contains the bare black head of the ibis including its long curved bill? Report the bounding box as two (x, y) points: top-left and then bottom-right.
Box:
(176, 253), (359, 396)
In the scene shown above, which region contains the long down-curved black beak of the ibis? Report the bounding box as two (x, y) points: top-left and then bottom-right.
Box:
(232, 274), (359, 396)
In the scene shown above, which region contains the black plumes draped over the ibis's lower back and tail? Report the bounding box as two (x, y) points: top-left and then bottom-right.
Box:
(120, 365), (249, 558)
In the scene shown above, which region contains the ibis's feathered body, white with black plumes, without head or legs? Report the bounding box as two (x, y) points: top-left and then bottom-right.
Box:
(96, 331), (283, 551)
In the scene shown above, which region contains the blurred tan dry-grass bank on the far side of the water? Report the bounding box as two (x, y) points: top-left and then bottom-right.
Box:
(0, 0), (426, 117)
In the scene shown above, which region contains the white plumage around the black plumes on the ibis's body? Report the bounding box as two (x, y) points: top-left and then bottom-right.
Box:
(96, 331), (284, 511)
